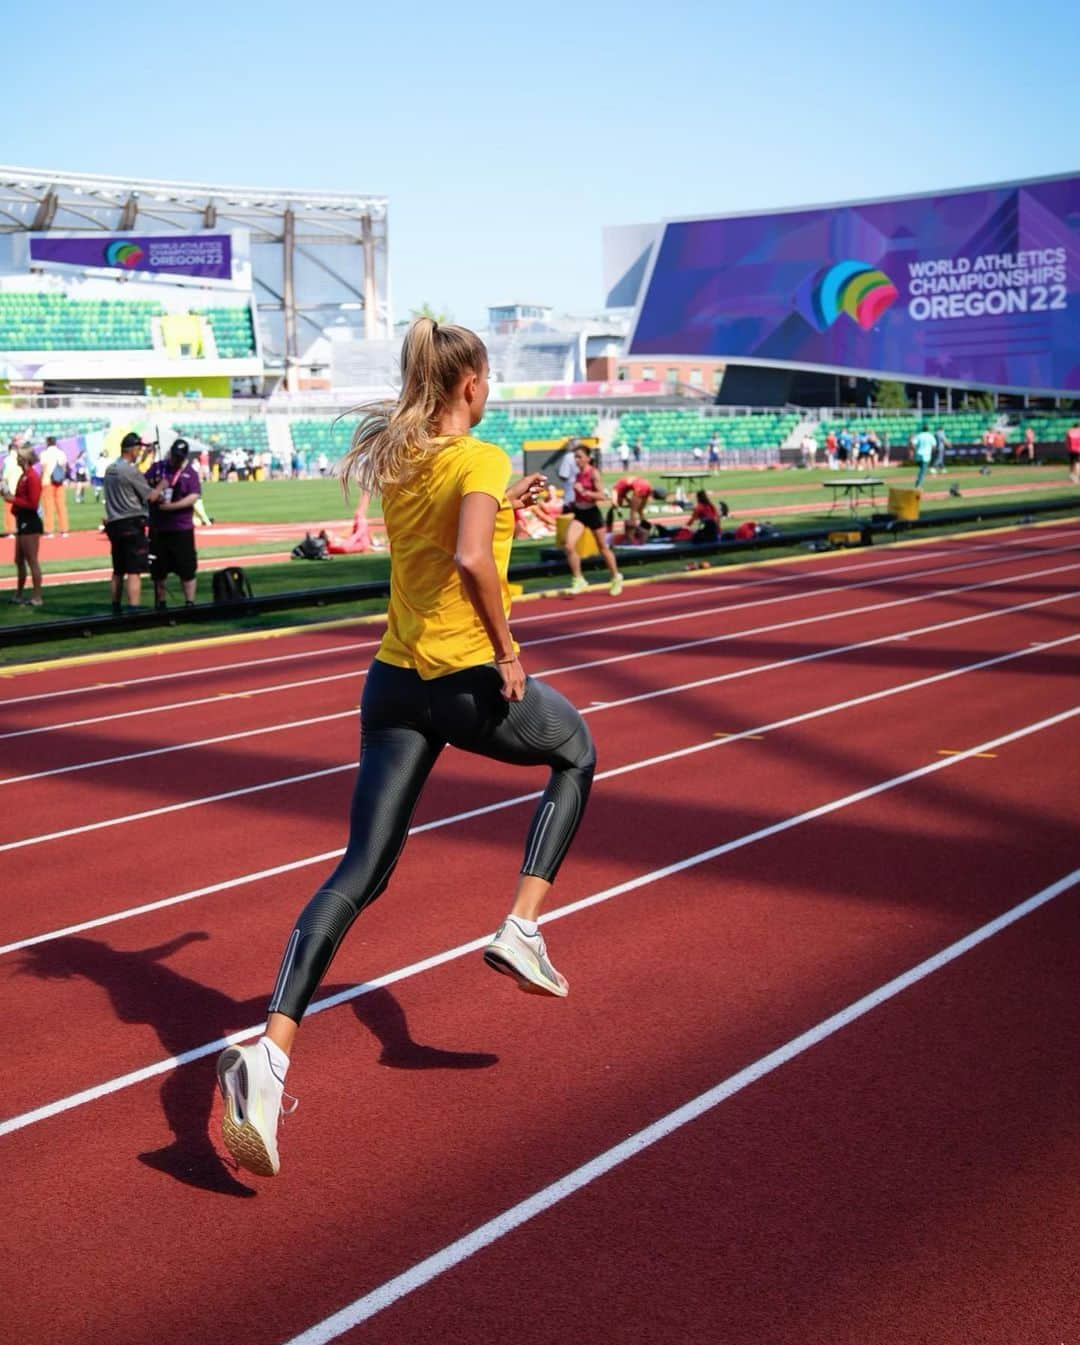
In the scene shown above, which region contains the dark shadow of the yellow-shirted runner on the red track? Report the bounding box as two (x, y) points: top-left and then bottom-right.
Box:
(19, 931), (499, 1197)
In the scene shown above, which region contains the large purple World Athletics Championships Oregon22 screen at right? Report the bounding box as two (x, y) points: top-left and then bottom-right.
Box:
(629, 178), (1080, 393)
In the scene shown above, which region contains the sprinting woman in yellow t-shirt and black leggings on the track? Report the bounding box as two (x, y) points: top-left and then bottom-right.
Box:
(218, 317), (596, 1177)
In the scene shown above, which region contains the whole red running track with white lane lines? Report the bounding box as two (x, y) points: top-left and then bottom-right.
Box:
(0, 527), (1080, 1345)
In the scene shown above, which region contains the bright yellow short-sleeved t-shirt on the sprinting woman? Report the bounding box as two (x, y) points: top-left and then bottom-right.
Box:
(375, 434), (516, 681)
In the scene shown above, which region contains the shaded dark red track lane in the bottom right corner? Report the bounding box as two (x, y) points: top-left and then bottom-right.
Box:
(332, 882), (1080, 1345)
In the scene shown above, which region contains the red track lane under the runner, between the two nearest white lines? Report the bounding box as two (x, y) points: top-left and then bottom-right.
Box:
(4, 740), (1068, 1345)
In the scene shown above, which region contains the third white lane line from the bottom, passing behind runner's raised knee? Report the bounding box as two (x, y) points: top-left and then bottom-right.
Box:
(0, 635), (1080, 956)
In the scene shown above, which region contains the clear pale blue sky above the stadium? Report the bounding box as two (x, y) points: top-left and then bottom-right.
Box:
(0, 0), (1080, 324)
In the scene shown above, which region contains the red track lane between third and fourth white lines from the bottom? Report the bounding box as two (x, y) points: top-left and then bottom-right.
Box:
(0, 591), (1076, 943)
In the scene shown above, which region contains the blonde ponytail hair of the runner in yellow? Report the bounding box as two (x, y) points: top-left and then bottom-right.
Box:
(338, 317), (487, 494)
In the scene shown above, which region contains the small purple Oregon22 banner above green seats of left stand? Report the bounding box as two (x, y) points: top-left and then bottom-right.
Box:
(30, 234), (233, 280)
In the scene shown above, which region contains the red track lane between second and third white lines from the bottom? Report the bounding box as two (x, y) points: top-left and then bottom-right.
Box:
(4, 655), (1076, 1111)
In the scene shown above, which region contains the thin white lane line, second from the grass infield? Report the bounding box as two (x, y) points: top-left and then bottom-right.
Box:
(0, 535), (1075, 742)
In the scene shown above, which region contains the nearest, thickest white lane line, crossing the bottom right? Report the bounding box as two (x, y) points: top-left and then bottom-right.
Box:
(286, 869), (1080, 1345)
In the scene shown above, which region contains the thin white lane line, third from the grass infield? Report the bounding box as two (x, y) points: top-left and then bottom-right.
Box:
(0, 547), (1080, 788)
